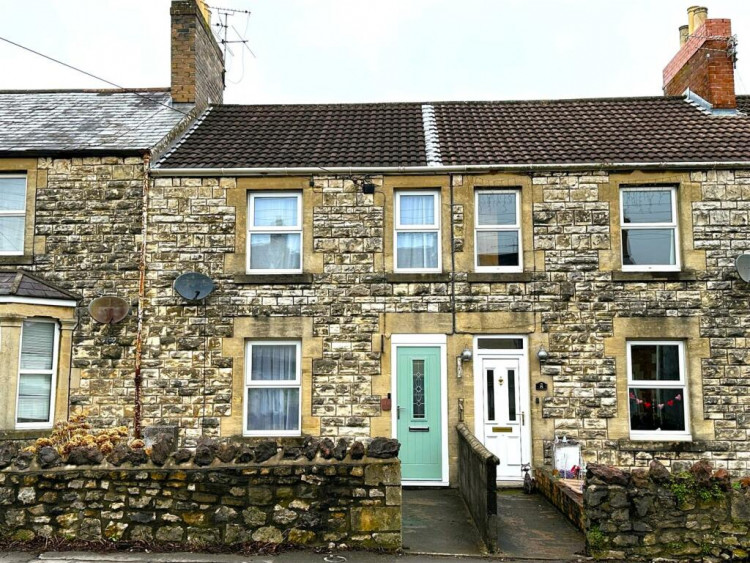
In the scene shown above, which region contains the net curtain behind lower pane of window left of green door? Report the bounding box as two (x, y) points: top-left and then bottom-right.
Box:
(247, 387), (299, 430)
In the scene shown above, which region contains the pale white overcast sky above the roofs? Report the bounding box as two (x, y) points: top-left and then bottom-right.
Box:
(0, 0), (750, 103)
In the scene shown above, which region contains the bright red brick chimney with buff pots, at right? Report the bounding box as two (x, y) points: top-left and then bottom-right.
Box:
(663, 6), (737, 109)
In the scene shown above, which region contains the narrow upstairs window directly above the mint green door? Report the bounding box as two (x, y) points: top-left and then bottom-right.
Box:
(394, 191), (441, 272)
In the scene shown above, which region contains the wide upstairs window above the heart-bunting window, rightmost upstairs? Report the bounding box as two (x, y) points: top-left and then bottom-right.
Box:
(620, 187), (680, 271)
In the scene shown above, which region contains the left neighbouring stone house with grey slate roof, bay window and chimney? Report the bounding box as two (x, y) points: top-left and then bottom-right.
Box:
(0, 0), (223, 438)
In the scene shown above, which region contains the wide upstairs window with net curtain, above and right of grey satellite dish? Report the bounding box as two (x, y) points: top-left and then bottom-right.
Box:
(247, 192), (302, 274)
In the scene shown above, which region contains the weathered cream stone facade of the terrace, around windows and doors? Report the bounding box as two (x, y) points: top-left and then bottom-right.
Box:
(1, 158), (750, 479)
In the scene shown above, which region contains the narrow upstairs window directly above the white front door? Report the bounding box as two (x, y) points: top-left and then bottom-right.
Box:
(474, 190), (523, 272)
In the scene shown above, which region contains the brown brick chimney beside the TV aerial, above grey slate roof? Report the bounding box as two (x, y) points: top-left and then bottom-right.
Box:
(169, 0), (224, 107)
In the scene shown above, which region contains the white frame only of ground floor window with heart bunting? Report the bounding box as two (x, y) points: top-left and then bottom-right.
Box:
(627, 340), (692, 441)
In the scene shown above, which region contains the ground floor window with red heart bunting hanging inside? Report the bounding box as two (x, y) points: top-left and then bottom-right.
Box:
(627, 341), (690, 440)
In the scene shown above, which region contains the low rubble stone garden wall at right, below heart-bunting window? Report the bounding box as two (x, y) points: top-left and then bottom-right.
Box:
(583, 461), (750, 561)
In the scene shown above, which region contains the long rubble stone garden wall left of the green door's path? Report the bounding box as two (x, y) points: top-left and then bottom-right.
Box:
(0, 440), (401, 549)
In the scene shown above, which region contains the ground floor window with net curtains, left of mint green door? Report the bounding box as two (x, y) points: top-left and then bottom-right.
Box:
(244, 341), (301, 436)
